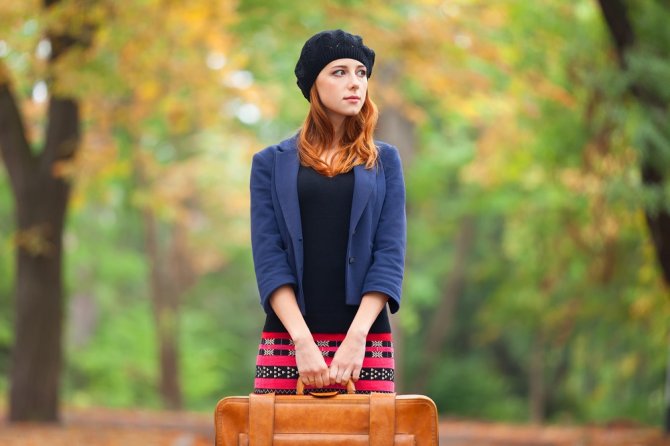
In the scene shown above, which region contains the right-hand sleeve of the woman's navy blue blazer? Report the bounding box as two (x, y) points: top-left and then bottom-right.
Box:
(362, 146), (407, 313)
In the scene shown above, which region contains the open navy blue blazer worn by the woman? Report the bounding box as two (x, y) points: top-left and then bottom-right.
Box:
(250, 135), (407, 314)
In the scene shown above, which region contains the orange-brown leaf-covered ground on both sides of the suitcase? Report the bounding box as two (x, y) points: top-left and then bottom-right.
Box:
(0, 409), (670, 446)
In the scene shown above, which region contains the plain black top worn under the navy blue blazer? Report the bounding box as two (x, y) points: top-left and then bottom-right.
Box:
(263, 165), (391, 333)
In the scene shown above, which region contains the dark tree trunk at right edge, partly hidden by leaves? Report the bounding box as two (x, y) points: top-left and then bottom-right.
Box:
(598, 0), (670, 433)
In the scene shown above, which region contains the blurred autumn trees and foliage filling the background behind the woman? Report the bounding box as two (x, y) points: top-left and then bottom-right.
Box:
(0, 0), (670, 444)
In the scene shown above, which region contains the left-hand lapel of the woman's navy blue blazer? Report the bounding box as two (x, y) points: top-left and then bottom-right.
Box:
(275, 149), (302, 241)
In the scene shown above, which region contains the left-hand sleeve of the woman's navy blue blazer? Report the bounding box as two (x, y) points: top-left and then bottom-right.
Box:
(249, 149), (298, 313)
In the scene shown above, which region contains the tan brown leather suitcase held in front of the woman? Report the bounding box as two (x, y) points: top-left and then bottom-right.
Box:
(214, 382), (438, 446)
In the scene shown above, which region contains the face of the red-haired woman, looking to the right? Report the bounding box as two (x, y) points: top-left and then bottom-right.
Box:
(315, 59), (368, 119)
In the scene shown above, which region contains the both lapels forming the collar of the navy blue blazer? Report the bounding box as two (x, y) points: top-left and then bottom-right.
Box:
(274, 136), (382, 244)
